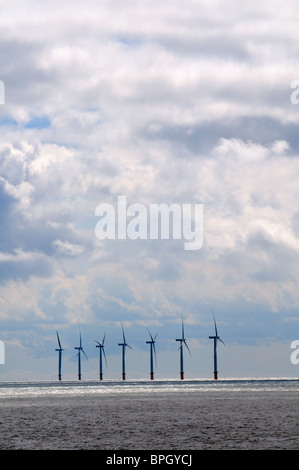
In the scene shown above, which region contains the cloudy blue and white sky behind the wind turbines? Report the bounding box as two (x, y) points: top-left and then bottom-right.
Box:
(0, 0), (299, 381)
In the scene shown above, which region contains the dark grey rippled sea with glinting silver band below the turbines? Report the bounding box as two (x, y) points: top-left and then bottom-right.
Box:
(0, 379), (299, 451)
